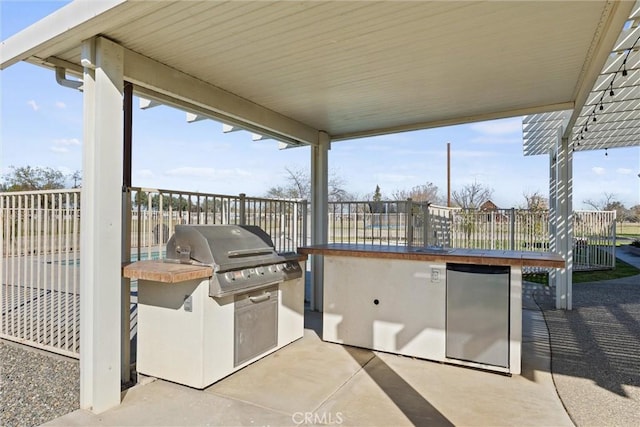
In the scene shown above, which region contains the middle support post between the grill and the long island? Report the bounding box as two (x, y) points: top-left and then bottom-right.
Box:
(311, 132), (331, 311)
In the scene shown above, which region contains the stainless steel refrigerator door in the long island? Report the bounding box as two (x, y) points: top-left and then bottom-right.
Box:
(446, 264), (510, 368)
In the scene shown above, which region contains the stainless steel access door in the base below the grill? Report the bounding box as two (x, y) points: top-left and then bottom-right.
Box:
(233, 287), (278, 366)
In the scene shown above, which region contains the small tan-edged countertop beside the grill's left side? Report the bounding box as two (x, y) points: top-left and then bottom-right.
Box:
(122, 260), (213, 283)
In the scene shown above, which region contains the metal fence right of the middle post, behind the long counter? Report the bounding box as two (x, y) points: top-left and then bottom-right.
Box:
(328, 199), (615, 270)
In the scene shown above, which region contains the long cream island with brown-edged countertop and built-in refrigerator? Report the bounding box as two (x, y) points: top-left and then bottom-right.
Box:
(298, 244), (565, 375)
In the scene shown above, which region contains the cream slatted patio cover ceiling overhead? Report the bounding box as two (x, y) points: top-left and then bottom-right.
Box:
(0, 0), (640, 147)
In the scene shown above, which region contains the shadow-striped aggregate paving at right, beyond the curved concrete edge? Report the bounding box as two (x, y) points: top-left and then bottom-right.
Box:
(536, 249), (640, 425)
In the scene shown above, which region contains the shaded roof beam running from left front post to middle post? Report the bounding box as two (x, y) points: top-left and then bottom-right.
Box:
(124, 43), (318, 144)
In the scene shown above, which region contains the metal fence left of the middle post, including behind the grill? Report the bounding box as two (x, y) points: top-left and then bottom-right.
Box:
(0, 188), (307, 358)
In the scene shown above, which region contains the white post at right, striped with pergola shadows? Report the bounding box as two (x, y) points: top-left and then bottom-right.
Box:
(551, 130), (573, 310)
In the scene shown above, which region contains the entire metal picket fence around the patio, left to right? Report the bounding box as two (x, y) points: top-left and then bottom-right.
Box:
(0, 188), (615, 357)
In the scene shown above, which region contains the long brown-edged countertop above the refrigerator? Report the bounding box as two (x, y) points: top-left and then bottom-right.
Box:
(298, 243), (565, 268)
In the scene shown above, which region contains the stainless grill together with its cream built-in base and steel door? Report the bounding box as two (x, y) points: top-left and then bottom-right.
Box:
(137, 225), (305, 388)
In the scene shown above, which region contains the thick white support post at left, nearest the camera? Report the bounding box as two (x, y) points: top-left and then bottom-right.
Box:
(80, 38), (124, 413)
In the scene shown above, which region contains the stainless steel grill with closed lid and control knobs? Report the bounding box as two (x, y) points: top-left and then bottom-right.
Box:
(166, 225), (302, 297)
